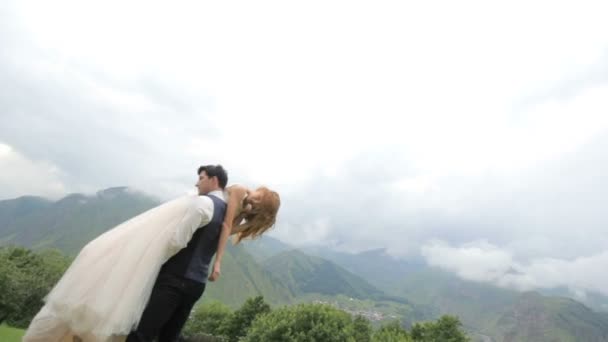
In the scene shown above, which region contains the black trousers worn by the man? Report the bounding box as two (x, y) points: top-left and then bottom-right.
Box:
(127, 274), (205, 342)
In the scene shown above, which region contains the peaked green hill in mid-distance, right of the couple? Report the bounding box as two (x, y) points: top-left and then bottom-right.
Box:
(264, 250), (383, 299)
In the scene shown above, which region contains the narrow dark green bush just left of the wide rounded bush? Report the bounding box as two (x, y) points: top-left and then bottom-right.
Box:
(224, 296), (270, 342)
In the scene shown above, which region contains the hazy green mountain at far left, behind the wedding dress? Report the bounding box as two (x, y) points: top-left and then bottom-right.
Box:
(0, 187), (159, 255)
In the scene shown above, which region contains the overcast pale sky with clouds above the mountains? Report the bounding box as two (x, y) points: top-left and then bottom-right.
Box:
(0, 0), (608, 293)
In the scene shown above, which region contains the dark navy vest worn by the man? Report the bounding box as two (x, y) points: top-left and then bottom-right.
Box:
(160, 195), (226, 283)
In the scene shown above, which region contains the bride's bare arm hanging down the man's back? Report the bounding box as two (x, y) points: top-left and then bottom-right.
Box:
(209, 185), (247, 281)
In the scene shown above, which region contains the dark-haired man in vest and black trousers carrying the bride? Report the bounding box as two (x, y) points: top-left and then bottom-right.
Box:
(127, 165), (229, 342)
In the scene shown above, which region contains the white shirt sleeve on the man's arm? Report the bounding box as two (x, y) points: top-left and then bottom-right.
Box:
(169, 196), (214, 253)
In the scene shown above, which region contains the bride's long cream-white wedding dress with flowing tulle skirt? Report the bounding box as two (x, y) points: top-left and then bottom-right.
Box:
(23, 195), (218, 342)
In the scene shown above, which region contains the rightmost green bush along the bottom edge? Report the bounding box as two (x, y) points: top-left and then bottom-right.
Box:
(412, 315), (469, 342)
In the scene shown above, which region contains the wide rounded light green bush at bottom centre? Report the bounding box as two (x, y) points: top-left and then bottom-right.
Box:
(243, 304), (355, 342)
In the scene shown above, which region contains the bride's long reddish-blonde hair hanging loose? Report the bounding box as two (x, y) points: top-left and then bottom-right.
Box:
(234, 186), (281, 244)
